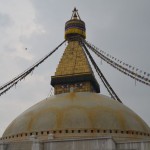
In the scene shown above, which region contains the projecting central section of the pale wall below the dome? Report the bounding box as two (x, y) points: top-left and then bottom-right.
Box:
(44, 138), (116, 150)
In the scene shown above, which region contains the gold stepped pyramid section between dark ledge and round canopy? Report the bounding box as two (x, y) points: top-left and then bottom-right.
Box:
(55, 41), (92, 76)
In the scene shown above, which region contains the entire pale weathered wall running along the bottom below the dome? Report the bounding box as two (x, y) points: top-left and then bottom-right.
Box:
(0, 137), (150, 150)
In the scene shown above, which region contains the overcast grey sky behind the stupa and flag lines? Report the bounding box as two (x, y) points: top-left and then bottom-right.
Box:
(0, 0), (150, 137)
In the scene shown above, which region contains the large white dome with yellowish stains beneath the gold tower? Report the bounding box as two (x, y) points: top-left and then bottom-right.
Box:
(3, 92), (150, 140)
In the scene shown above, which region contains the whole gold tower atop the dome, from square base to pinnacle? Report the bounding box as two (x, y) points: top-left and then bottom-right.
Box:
(51, 9), (100, 94)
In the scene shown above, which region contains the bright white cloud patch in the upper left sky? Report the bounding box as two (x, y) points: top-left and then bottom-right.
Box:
(0, 0), (45, 60)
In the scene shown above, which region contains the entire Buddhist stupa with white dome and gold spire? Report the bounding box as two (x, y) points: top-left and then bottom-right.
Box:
(0, 8), (150, 150)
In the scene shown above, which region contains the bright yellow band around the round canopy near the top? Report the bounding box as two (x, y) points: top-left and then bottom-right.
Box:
(65, 28), (86, 39)
